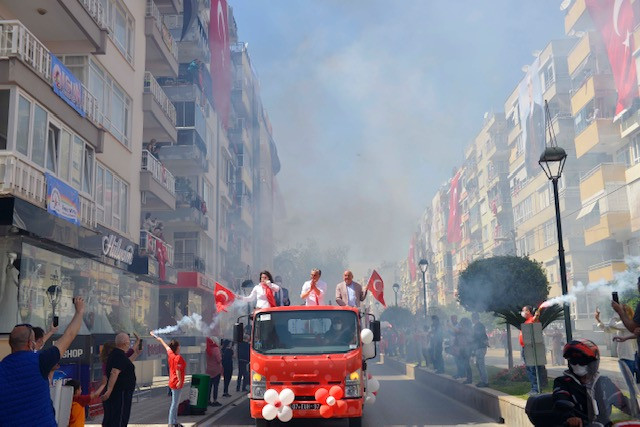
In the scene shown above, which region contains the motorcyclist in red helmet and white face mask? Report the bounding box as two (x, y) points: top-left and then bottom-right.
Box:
(553, 339), (631, 427)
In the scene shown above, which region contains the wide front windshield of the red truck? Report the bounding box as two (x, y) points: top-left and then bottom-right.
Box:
(253, 310), (359, 354)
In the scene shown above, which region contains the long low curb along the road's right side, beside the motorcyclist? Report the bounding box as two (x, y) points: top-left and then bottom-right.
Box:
(384, 357), (532, 426)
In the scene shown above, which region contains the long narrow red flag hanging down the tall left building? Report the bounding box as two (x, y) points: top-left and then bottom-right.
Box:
(209, 0), (231, 129)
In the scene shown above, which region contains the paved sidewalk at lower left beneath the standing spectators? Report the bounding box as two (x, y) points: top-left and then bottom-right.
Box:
(85, 376), (247, 427)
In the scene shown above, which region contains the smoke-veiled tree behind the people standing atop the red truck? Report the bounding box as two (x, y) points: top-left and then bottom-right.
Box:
(272, 240), (349, 304)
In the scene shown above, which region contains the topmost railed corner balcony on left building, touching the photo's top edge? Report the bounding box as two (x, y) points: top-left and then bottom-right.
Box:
(144, 0), (178, 77)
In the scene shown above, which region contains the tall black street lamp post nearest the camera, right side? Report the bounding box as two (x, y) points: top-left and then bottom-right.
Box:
(538, 146), (572, 342)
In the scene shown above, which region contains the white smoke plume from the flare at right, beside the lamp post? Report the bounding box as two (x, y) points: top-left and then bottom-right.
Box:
(540, 257), (640, 308)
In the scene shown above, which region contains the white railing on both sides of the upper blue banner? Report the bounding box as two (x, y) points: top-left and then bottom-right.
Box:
(0, 20), (102, 126)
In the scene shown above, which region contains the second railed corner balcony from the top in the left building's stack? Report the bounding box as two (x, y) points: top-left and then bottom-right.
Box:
(142, 71), (178, 142)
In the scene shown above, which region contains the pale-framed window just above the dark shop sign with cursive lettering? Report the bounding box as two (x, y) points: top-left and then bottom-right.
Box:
(95, 164), (129, 233)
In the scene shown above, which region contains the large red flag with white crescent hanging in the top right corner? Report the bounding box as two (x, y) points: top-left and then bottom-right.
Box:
(585, 0), (638, 117)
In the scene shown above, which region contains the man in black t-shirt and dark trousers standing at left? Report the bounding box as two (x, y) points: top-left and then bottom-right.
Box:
(102, 332), (136, 427)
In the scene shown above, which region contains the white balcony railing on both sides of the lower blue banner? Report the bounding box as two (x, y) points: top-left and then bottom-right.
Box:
(0, 152), (96, 228)
